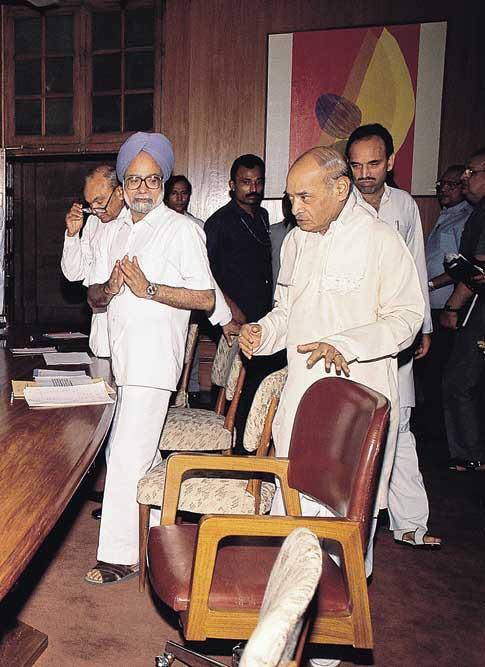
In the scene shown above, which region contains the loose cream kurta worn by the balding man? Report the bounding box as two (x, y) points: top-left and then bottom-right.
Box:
(256, 194), (424, 507)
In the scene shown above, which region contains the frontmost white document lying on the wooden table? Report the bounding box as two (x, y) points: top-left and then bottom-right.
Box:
(24, 382), (114, 408)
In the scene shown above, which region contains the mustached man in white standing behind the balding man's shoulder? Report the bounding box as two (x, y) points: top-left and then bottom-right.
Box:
(346, 123), (441, 549)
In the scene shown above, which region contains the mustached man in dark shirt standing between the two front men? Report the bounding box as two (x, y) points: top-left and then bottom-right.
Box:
(204, 154), (286, 453)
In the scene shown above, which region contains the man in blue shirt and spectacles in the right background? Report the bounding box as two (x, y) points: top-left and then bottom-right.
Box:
(416, 164), (473, 440)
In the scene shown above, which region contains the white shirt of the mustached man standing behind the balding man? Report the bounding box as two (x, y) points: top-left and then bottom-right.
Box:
(354, 185), (433, 408)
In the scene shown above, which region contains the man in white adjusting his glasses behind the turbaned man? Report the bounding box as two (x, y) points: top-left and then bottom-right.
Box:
(61, 164), (124, 357)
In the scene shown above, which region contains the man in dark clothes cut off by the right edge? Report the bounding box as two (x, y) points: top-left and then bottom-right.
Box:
(440, 147), (485, 472)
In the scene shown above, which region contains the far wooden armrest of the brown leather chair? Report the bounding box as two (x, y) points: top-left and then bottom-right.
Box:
(160, 453), (301, 525)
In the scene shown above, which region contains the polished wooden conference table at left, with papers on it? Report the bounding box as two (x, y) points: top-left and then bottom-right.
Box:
(0, 342), (114, 667)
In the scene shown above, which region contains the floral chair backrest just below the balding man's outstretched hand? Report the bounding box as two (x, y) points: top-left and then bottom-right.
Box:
(243, 367), (288, 455)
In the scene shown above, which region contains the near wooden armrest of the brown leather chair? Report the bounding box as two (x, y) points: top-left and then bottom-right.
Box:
(188, 515), (364, 636)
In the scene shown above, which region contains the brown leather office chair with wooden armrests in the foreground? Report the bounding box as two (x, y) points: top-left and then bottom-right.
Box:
(148, 378), (389, 648)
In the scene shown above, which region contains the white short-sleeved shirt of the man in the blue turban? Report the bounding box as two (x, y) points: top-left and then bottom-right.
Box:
(89, 204), (214, 391)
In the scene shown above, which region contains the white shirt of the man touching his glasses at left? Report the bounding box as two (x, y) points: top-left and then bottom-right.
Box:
(61, 215), (110, 357)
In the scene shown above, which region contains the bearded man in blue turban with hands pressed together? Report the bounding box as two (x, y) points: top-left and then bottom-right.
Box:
(86, 132), (214, 584)
